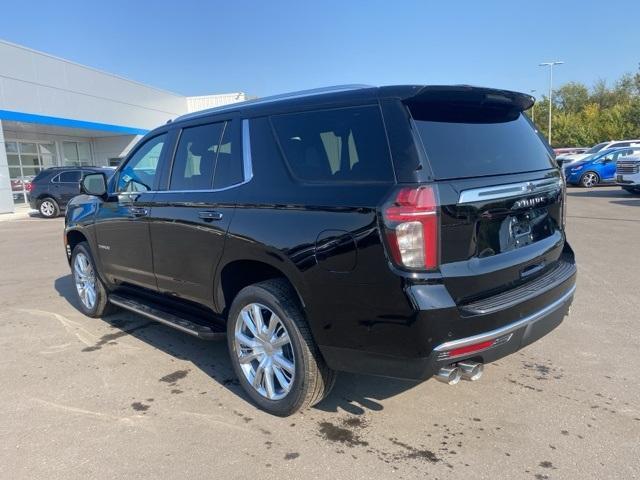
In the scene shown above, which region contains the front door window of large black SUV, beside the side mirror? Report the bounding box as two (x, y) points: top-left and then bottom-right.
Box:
(118, 133), (167, 192)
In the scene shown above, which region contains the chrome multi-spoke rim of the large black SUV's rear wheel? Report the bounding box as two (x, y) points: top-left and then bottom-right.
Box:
(234, 303), (296, 400)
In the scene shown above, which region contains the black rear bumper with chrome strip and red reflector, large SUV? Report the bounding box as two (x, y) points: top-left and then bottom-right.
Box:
(321, 253), (576, 380)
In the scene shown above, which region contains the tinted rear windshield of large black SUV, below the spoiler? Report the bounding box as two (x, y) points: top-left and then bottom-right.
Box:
(410, 104), (554, 179)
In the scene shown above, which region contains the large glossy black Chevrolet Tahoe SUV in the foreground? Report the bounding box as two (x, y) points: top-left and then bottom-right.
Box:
(65, 86), (576, 415)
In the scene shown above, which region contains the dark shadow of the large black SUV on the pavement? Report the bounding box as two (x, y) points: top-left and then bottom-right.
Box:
(54, 275), (417, 415)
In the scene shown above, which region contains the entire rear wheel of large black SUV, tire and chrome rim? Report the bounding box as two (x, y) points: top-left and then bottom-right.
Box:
(227, 279), (336, 417)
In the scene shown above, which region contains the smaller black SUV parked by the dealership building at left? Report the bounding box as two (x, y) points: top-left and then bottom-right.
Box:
(28, 167), (114, 218)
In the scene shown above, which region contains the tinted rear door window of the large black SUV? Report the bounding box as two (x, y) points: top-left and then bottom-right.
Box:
(169, 122), (225, 190)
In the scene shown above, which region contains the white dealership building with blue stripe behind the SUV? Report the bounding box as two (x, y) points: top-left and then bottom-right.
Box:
(0, 40), (246, 213)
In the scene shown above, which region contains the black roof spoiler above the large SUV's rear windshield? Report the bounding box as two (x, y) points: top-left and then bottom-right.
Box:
(403, 85), (535, 112)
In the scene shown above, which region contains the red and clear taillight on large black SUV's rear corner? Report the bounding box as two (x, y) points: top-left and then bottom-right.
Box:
(382, 185), (439, 270)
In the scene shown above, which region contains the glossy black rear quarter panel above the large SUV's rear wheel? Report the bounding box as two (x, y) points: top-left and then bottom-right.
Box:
(219, 118), (407, 348)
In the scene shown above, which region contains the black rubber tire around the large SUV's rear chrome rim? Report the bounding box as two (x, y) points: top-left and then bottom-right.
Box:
(227, 279), (336, 417)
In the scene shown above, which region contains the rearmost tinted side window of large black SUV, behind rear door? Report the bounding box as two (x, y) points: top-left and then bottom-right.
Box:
(271, 106), (394, 182)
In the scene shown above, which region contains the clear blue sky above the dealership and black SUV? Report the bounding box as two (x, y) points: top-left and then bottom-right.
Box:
(0, 0), (640, 96)
